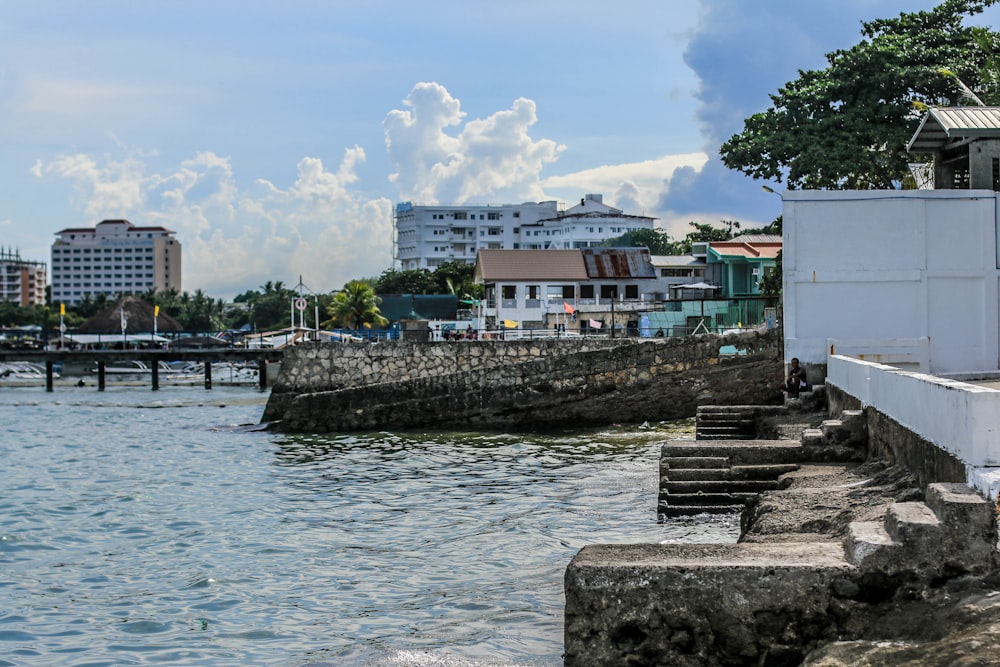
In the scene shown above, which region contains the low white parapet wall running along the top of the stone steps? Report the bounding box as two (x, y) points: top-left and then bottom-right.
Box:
(827, 355), (1000, 498)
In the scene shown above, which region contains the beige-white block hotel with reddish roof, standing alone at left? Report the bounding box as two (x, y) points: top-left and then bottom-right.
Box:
(52, 220), (181, 304)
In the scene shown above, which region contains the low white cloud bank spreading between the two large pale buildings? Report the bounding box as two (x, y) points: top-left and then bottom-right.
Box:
(32, 147), (392, 297)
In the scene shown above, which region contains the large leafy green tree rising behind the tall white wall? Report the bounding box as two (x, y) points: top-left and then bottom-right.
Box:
(720, 0), (997, 189)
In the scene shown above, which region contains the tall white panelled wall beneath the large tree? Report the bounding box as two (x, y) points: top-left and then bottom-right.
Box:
(782, 190), (1000, 373)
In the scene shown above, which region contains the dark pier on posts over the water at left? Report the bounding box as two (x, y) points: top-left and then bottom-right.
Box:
(0, 348), (283, 391)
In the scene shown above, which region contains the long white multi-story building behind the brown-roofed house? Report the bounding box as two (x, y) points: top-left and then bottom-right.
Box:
(393, 195), (656, 271)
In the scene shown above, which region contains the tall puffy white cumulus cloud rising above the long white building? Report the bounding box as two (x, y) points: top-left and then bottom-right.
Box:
(384, 83), (565, 204)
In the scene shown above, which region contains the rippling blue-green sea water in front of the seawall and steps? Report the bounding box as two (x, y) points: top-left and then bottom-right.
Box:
(0, 387), (738, 667)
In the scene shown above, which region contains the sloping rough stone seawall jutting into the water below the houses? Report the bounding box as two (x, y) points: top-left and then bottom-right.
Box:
(263, 332), (782, 432)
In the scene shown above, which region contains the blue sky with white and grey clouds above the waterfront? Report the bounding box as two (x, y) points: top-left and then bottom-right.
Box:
(0, 0), (1000, 299)
